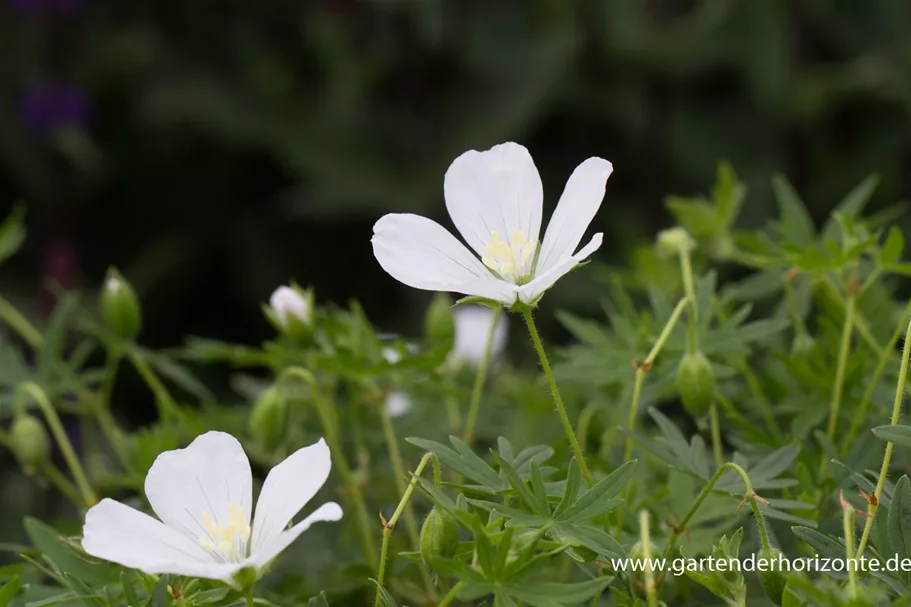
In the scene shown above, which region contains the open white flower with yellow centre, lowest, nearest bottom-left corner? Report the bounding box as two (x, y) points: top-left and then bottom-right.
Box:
(82, 432), (342, 587)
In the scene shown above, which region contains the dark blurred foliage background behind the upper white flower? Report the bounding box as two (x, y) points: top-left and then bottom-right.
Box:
(0, 0), (911, 358)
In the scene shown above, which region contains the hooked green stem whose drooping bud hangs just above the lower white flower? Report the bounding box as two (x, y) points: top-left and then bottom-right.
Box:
(276, 367), (376, 569)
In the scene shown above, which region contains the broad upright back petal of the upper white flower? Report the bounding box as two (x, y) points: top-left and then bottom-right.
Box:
(443, 143), (544, 257)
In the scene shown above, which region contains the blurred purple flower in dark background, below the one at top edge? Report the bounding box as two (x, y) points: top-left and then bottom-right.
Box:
(21, 84), (91, 136)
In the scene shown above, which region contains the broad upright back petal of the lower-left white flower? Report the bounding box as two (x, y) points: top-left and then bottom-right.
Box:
(145, 432), (253, 538)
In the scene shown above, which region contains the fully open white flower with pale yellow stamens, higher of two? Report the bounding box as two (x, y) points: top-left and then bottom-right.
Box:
(373, 143), (613, 306)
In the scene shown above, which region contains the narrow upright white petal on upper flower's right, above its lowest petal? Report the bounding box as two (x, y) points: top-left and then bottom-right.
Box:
(535, 158), (613, 276)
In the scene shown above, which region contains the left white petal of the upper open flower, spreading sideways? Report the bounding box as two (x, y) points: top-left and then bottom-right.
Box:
(372, 213), (493, 292)
